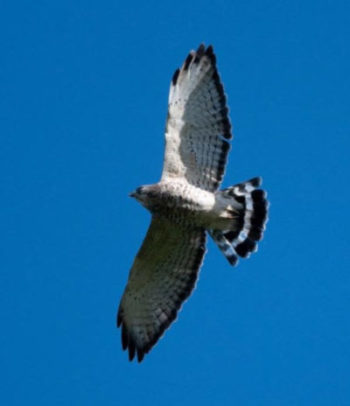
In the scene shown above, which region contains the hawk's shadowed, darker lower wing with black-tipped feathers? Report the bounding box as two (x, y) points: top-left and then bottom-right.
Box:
(117, 217), (206, 362)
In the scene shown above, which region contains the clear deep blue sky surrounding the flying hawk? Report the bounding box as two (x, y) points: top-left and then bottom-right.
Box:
(0, 0), (350, 406)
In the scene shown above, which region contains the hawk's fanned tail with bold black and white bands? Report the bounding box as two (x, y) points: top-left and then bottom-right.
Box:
(209, 178), (268, 265)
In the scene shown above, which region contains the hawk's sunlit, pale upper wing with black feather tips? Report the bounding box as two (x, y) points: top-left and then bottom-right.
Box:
(162, 44), (232, 191)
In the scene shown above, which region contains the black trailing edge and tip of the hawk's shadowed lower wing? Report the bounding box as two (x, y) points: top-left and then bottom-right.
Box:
(117, 230), (206, 362)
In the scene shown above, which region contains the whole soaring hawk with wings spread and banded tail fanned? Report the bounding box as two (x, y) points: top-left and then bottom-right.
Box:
(117, 44), (268, 362)
